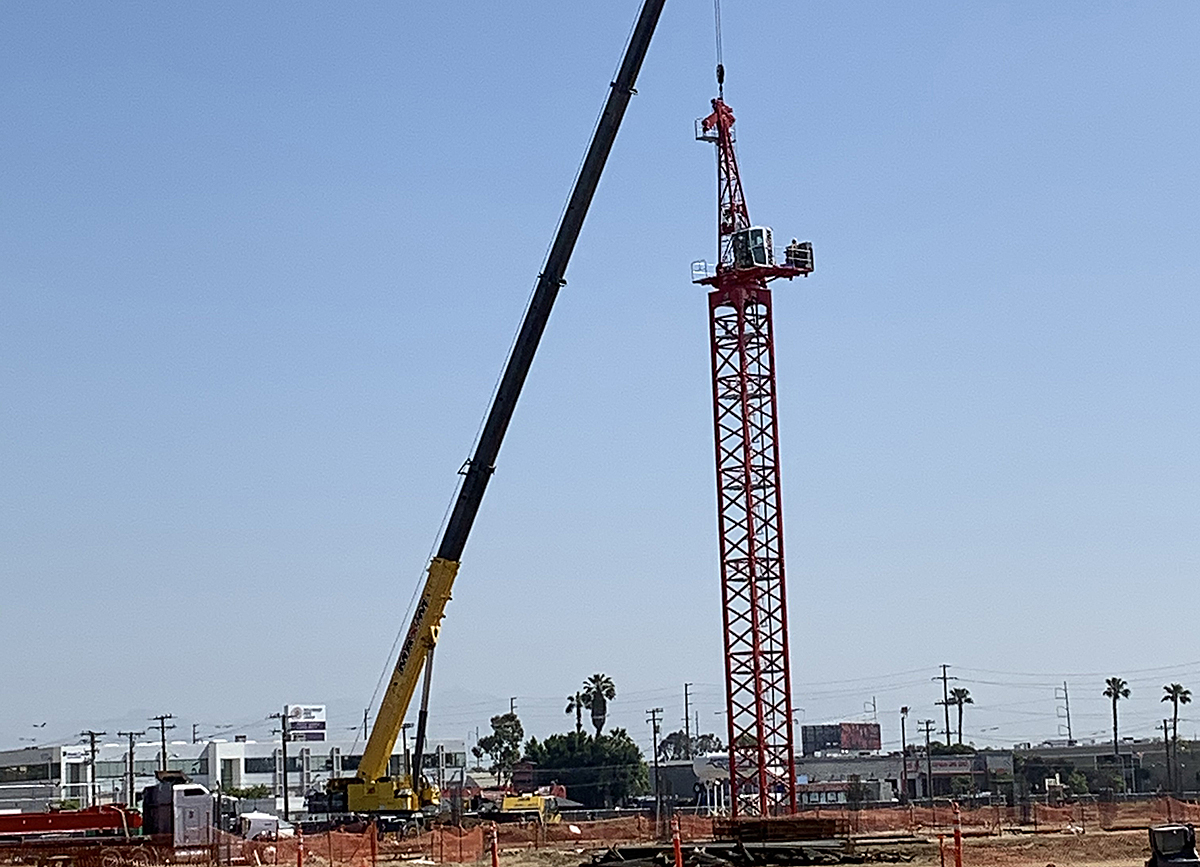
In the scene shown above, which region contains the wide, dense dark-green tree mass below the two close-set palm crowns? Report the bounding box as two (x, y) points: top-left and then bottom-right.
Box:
(524, 729), (649, 809)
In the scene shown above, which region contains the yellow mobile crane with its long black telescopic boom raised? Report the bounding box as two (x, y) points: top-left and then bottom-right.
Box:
(321, 0), (665, 818)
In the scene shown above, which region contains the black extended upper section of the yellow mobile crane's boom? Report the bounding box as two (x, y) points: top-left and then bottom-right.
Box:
(437, 0), (666, 562)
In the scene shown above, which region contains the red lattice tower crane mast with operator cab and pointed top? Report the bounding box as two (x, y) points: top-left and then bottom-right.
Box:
(694, 87), (812, 818)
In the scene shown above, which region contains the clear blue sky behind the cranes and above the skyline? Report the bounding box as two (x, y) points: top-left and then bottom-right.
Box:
(0, 0), (1200, 747)
